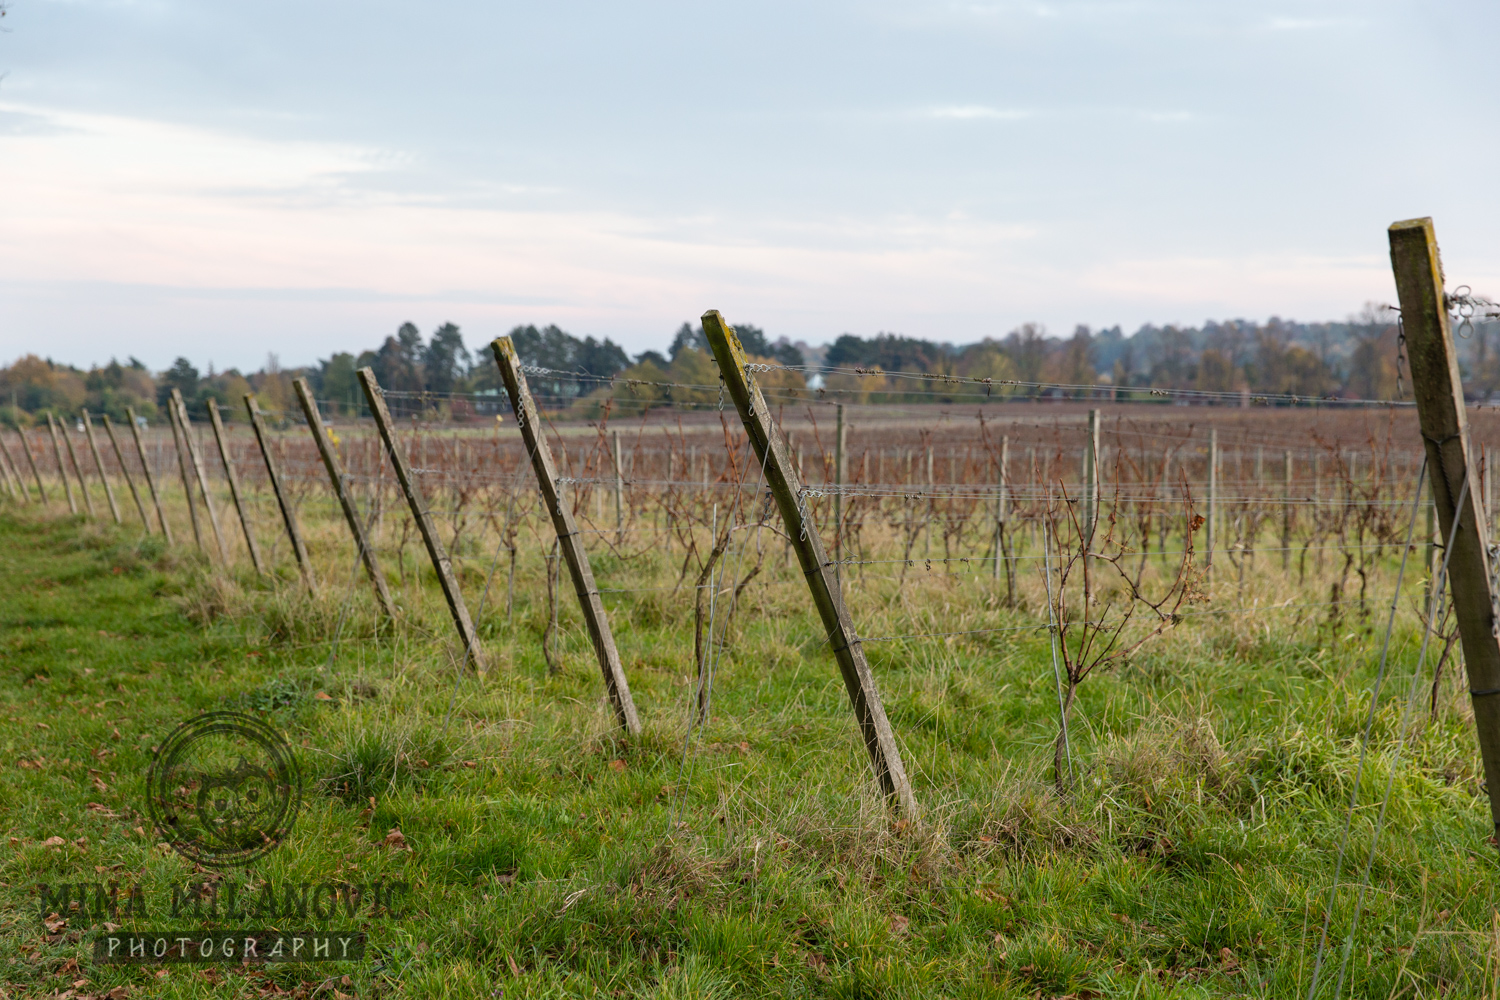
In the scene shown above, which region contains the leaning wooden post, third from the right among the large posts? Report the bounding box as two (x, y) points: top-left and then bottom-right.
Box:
(491, 337), (641, 733)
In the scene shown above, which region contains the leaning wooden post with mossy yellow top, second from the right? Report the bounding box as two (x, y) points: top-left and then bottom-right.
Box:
(704, 309), (912, 816)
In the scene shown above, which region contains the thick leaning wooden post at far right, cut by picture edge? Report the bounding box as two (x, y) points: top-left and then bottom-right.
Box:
(1389, 219), (1500, 837)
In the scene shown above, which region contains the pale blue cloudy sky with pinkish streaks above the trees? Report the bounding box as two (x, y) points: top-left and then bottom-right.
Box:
(0, 0), (1500, 370)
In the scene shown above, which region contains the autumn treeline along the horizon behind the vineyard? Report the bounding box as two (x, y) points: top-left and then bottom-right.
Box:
(0, 306), (1500, 427)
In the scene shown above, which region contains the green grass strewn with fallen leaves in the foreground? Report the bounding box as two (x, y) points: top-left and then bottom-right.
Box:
(0, 516), (1500, 1000)
